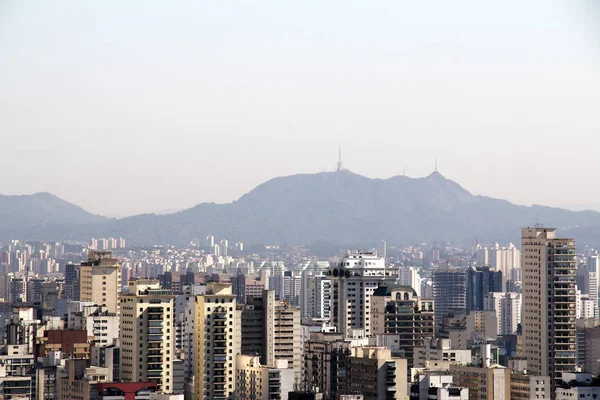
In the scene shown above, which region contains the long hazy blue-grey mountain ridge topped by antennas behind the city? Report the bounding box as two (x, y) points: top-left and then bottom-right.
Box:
(0, 171), (600, 246)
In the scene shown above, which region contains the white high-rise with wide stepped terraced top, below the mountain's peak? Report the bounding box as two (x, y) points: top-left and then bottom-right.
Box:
(327, 252), (398, 337)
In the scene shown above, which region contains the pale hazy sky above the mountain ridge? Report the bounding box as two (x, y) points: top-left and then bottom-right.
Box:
(0, 0), (600, 216)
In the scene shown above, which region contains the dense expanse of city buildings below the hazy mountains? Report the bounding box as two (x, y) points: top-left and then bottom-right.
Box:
(0, 225), (600, 400)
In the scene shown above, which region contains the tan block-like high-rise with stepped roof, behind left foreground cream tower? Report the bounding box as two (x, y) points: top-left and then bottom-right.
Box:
(79, 250), (121, 314)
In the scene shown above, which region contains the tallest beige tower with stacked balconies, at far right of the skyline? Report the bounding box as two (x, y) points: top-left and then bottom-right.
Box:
(520, 227), (577, 387)
